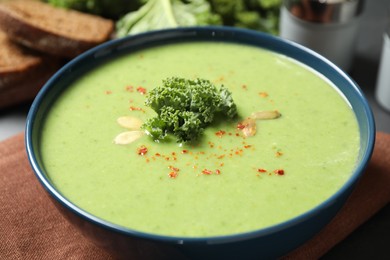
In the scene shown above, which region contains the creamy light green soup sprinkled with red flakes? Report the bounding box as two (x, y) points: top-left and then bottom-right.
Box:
(40, 42), (359, 237)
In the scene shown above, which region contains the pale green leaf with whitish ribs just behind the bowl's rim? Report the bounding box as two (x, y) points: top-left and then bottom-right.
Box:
(116, 0), (222, 37)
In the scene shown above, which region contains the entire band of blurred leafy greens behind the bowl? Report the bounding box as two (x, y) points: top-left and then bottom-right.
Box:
(42, 0), (282, 37)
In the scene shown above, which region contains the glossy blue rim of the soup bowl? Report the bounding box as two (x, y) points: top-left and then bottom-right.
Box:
(25, 26), (375, 244)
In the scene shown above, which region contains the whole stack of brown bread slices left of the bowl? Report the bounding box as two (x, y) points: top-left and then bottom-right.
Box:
(0, 0), (114, 107)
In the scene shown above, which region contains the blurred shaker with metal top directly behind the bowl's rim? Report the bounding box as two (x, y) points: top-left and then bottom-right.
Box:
(280, 0), (364, 71)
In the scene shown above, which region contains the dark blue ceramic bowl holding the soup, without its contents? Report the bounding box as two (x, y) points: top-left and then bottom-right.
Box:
(26, 27), (375, 259)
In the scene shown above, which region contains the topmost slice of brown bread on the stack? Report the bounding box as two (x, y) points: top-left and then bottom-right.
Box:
(0, 0), (114, 58)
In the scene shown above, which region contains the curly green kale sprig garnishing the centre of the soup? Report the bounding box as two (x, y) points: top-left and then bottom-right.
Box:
(142, 77), (237, 143)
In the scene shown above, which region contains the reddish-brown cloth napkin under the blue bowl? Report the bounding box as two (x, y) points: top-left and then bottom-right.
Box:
(0, 133), (390, 260)
